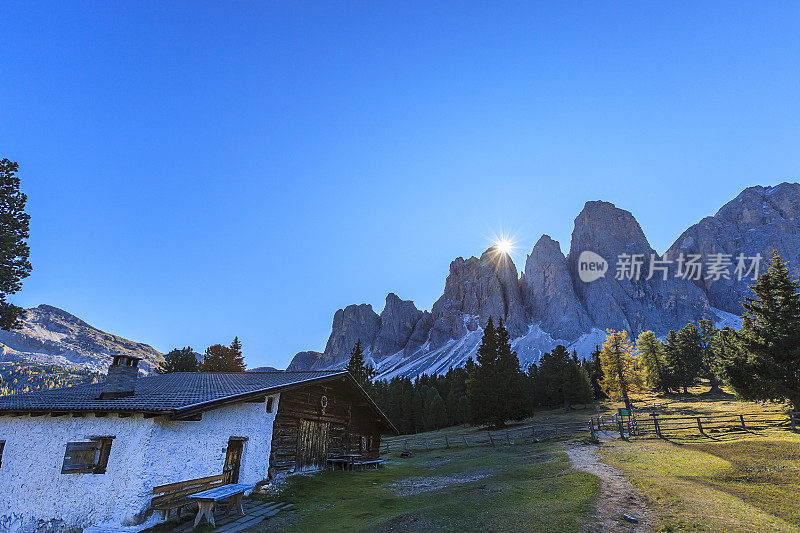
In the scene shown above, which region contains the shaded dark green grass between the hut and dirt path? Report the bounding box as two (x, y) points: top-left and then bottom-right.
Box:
(264, 443), (597, 532)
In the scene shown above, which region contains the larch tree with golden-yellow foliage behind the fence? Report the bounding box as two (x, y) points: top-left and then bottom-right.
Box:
(600, 329), (644, 410)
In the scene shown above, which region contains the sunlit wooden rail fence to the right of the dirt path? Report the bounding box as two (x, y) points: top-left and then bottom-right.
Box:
(589, 412), (800, 438)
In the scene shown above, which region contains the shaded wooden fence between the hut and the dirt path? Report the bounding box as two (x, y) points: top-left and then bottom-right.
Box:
(381, 421), (590, 453)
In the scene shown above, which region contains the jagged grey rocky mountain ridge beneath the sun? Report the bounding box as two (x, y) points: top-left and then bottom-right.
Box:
(289, 182), (800, 378)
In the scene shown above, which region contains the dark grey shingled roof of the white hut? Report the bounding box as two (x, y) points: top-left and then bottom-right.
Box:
(0, 370), (346, 415)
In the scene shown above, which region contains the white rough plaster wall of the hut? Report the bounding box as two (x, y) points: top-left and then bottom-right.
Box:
(0, 395), (278, 533)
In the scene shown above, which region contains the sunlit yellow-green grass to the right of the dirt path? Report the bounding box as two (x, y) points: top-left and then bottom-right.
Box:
(602, 380), (800, 533)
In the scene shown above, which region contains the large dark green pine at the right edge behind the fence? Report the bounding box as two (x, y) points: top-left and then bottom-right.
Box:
(723, 252), (800, 410)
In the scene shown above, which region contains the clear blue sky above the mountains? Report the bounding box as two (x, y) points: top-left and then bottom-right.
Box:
(0, 1), (800, 367)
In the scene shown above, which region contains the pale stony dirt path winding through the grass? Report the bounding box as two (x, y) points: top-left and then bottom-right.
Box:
(566, 436), (653, 533)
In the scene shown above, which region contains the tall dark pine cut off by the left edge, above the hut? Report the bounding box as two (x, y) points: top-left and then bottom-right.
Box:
(0, 159), (31, 330)
